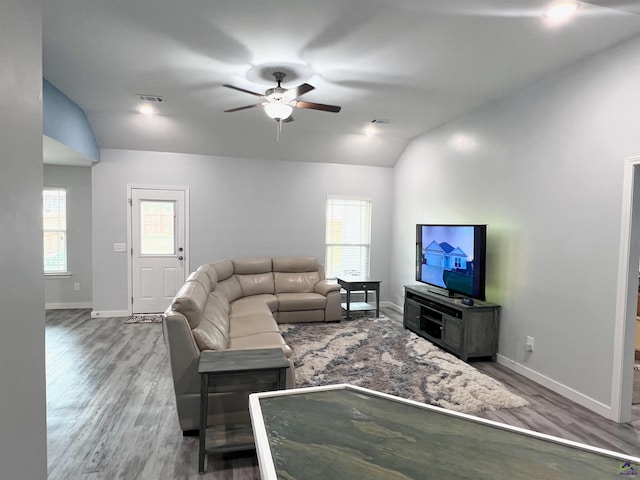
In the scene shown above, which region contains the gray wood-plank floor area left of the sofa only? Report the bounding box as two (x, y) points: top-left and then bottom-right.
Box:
(46, 310), (260, 480)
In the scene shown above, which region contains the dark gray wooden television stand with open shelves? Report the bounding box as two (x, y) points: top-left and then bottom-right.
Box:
(403, 285), (500, 362)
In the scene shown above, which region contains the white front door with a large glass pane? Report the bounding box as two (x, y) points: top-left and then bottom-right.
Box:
(130, 187), (188, 313)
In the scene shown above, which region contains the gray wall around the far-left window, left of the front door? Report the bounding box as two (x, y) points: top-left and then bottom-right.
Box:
(44, 165), (93, 308)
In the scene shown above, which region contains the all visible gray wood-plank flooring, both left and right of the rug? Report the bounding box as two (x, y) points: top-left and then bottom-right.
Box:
(46, 309), (640, 480)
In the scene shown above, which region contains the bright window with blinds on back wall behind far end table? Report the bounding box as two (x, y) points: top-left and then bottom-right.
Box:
(325, 197), (371, 278)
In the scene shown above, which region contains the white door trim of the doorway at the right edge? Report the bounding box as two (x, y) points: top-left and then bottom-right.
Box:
(611, 157), (640, 423)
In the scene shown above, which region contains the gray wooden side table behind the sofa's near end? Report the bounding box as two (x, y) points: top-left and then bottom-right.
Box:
(198, 348), (289, 474)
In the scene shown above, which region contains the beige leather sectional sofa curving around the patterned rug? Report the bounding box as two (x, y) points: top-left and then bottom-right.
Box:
(162, 257), (341, 432)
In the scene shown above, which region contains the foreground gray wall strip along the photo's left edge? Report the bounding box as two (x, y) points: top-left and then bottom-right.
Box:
(0, 0), (47, 480)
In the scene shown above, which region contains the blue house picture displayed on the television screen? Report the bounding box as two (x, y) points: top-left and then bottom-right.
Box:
(420, 226), (474, 293)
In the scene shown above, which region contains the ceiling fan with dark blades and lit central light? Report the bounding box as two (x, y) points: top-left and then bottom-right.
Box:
(223, 72), (341, 123)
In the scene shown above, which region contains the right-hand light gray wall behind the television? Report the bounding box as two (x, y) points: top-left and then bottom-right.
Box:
(390, 39), (640, 412)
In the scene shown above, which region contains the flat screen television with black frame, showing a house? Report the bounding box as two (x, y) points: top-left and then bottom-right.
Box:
(416, 224), (487, 300)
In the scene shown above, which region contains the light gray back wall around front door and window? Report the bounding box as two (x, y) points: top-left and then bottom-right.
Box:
(92, 150), (392, 312)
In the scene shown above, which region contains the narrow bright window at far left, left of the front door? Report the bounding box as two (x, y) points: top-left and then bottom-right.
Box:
(42, 188), (67, 274)
